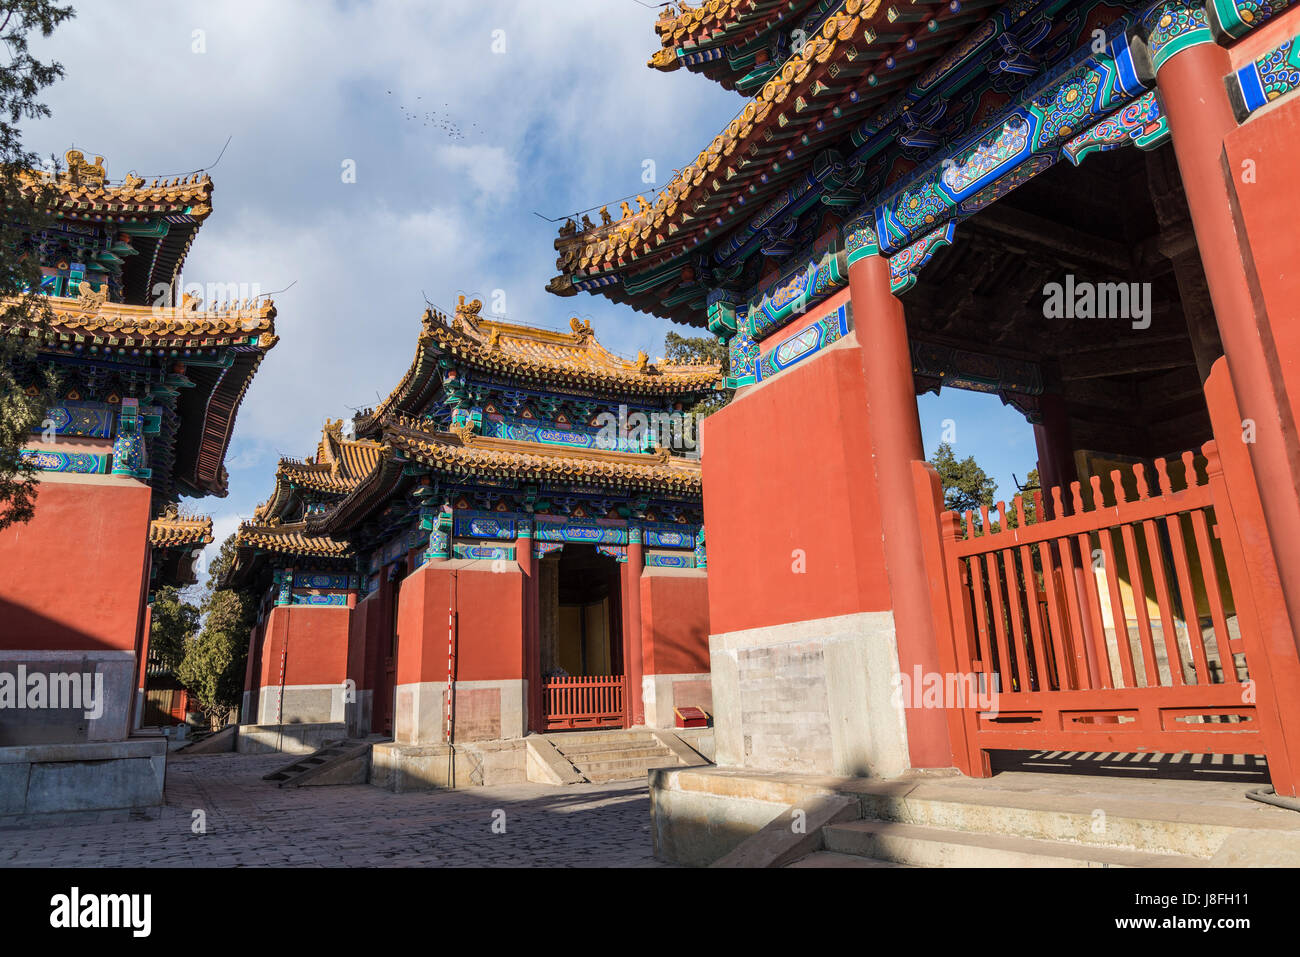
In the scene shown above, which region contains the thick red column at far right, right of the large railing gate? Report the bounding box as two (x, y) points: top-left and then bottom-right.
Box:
(1149, 14), (1300, 655)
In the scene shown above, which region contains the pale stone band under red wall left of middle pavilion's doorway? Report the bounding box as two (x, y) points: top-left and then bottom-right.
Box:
(393, 679), (528, 745)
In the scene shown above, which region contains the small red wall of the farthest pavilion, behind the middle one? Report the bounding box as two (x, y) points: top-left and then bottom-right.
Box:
(261, 605), (352, 688)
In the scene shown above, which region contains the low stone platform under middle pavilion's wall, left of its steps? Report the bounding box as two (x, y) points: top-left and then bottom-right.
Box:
(371, 739), (528, 792)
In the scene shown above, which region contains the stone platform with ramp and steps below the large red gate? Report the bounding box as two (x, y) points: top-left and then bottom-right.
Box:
(651, 768), (1300, 867)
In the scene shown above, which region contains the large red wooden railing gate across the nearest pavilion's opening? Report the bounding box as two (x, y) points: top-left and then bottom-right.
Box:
(941, 442), (1265, 774)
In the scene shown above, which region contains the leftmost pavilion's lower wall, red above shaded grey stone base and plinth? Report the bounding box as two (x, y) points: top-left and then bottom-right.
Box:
(0, 473), (166, 820)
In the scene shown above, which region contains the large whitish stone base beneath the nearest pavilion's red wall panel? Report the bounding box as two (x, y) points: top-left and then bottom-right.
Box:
(709, 611), (909, 778)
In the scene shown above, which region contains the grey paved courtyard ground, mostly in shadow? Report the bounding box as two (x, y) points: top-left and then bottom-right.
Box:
(0, 754), (666, 867)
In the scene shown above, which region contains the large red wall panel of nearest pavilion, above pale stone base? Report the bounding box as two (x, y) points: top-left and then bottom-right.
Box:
(702, 341), (894, 635)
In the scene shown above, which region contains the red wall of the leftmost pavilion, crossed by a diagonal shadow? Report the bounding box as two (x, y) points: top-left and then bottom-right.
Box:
(0, 479), (151, 651)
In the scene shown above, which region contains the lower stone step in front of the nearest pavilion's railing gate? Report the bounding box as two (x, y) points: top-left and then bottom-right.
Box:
(822, 820), (1205, 867)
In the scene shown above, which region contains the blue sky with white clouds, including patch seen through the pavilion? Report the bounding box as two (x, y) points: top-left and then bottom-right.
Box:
(25, 0), (1034, 574)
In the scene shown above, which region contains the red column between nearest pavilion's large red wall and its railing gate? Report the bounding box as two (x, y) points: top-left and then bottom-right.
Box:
(845, 220), (953, 767)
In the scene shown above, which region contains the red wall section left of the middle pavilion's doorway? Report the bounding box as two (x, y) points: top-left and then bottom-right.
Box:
(398, 562), (524, 684)
